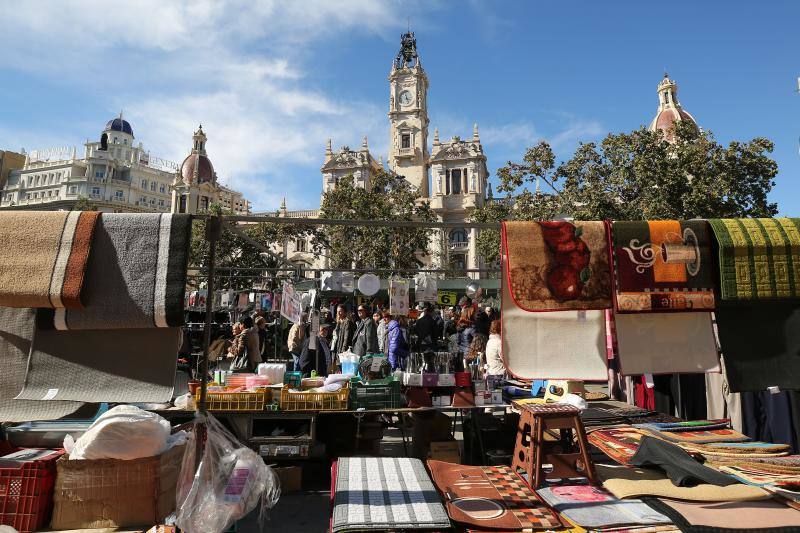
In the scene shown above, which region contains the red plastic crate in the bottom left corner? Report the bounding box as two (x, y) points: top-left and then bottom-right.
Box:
(0, 446), (63, 533)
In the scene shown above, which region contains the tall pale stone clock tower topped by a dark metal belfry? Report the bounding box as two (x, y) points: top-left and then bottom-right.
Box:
(389, 32), (430, 198)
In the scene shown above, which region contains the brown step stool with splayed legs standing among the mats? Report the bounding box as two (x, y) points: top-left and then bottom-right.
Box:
(511, 404), (597, 489)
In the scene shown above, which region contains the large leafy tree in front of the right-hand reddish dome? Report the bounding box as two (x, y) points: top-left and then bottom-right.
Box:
(473, 122), (778, 263)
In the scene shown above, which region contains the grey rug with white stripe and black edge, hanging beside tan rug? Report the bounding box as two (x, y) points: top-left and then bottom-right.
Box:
(38, 213), (191, 330)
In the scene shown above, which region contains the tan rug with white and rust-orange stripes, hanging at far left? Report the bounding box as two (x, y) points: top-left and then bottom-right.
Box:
(0, 211), (100, 309)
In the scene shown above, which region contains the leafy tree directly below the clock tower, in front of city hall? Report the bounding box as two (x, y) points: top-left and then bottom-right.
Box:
(320, 171), (436, 271)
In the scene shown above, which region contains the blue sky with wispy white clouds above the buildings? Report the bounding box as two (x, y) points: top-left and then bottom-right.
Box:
(0, 0), (800, 216)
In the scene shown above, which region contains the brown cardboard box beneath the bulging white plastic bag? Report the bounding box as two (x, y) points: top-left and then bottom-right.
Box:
(51, 446), (185, 529)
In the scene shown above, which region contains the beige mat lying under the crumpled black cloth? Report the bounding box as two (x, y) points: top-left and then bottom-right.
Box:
(596, 465), (771, 502)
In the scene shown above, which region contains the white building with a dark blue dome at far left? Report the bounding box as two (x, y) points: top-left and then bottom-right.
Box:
(0, 113), (249, 212)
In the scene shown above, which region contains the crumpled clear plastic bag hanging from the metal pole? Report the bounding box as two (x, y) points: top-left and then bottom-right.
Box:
(175, 413), (281, 533)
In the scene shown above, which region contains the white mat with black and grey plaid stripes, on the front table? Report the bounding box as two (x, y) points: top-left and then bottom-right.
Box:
(331, 457), (450, 533)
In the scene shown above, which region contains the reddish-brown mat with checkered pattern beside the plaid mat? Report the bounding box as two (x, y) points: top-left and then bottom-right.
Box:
(428, 460), (563, 531)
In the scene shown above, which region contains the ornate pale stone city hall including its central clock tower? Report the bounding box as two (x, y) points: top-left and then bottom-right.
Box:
(278, 32), (489, 277)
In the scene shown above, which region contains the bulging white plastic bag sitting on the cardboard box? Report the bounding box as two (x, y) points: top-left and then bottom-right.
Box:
(65, 405), (171, 461)
